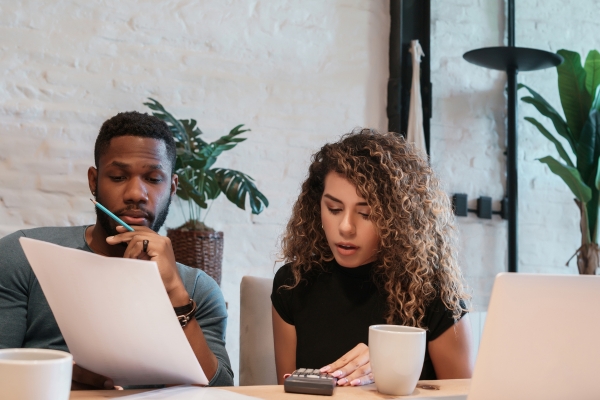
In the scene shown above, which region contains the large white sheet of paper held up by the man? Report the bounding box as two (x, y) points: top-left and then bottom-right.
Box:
(19, 238), (208, 386)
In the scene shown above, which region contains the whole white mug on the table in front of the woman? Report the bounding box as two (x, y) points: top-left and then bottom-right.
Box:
(369, 325), (425, 396)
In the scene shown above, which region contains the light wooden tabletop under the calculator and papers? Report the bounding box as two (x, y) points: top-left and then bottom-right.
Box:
(70, 379), (471, 400)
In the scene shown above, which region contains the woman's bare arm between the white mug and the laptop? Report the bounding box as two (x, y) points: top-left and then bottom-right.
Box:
(428, 314), (473, 379)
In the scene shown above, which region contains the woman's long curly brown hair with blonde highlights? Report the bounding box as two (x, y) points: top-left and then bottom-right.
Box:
(281, 129), (470, 328)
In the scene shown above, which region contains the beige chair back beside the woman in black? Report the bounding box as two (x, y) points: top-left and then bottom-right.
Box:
(239, 276), (277, 386)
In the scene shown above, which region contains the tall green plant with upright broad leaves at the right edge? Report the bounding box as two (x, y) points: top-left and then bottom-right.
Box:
(519, 50), (600, 275)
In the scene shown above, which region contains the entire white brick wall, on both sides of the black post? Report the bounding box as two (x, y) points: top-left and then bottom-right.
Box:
(0, 0), (600, 384)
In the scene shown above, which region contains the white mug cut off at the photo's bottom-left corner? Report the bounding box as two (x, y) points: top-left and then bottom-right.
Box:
(0, 349), (73, 400)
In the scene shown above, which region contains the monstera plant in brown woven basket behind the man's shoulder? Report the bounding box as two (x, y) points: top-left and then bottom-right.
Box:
(144, 98), (269, 285)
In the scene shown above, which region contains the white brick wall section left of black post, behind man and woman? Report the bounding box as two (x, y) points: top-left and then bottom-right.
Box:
(0, 0), (389, 384)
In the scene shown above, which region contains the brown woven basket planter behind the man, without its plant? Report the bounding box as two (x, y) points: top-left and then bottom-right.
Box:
(167, 229), (223, 286)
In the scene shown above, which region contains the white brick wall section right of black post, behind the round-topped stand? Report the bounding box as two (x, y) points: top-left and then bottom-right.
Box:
(431, 0), (600, 310)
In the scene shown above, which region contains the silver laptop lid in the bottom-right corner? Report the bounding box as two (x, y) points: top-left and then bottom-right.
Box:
(468, 273), (600, 400)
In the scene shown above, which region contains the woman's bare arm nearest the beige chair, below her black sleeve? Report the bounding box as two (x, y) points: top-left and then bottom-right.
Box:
(271, 306), (296, 385)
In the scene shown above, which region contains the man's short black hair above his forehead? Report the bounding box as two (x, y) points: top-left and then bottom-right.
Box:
(94, 111), (177, 172)
